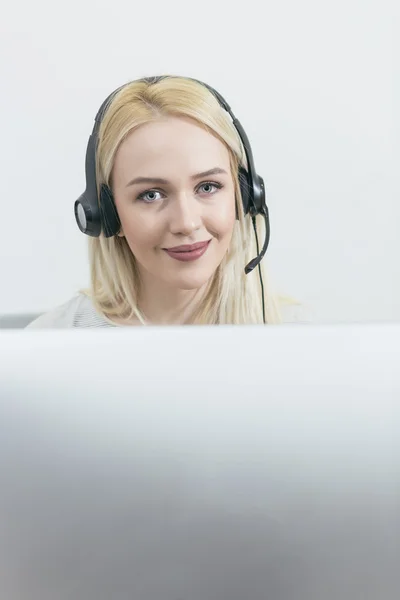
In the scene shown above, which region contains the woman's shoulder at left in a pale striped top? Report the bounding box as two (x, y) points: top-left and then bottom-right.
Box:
(26, 293), (112, 329)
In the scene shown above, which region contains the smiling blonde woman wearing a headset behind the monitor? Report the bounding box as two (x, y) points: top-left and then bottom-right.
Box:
(29, 76), (290, 328)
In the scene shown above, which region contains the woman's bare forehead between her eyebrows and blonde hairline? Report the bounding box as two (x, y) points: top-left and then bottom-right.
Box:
(114, 117), (229, 177)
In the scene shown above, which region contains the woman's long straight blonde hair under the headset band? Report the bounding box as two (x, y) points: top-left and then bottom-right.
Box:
(84, 77), (281, 325)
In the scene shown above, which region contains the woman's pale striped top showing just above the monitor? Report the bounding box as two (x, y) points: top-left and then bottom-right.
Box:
(27, 294), (307, 329)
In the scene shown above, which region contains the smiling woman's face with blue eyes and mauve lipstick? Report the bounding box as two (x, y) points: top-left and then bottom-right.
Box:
(112, 117), (236, 290)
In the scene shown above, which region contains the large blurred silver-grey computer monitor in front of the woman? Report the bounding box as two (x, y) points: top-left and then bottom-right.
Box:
(0, 325), (400, 600)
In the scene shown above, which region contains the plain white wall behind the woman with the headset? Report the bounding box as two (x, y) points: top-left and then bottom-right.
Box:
(0, 0), (400, 322)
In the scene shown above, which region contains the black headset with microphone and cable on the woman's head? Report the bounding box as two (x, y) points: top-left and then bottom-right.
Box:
(74, 75), (270, 323)
